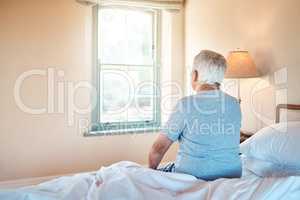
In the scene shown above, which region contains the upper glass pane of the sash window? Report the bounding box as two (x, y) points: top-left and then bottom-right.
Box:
(99, 8), (153, 65)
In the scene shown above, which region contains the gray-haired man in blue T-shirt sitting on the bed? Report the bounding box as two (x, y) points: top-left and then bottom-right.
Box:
(149, 50), (241, 181)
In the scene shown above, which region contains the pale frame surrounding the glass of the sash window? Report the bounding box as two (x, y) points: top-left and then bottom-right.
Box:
(86, 5), (162, 136)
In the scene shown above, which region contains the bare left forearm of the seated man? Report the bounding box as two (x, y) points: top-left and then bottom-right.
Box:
(149, 134), (173, 169)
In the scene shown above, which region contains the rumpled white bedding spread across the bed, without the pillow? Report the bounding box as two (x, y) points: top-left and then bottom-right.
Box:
(0, 162), (300, 200)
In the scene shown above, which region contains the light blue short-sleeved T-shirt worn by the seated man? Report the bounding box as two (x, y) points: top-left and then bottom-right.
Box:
(162, 90), (241, 180)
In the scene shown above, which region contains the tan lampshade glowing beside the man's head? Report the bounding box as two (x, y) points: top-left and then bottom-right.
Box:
(225, 51), (259, 78)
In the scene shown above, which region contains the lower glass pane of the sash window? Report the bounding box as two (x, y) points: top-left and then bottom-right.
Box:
(100, 65), (155, 123)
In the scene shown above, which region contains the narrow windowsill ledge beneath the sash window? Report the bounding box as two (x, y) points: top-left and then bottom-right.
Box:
(84, 127), (161, 137)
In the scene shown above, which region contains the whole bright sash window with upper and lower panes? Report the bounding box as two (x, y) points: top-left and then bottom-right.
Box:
(91, 6), (160, 134)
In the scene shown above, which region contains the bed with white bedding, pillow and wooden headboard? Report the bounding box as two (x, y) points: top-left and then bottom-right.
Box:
(0, 105), (300, 200)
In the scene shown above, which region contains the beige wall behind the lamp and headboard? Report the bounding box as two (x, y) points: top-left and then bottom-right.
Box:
(185, 0), (300, 131)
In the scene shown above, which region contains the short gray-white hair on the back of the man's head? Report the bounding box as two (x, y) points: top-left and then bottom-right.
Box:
(193, 50), (227, 84)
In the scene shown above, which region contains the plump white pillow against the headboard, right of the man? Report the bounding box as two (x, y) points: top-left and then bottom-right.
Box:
(241, 122), (300, 177)
